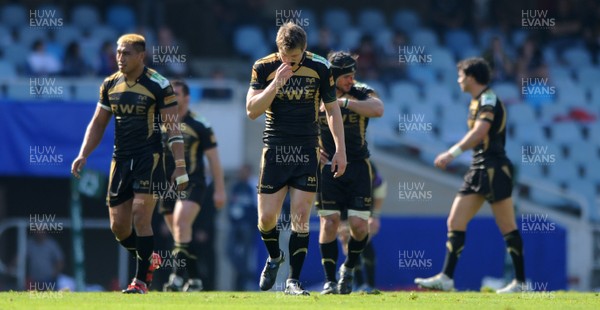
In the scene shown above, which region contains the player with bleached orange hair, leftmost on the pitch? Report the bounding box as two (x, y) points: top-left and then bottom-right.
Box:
(71, 34), (189, 294)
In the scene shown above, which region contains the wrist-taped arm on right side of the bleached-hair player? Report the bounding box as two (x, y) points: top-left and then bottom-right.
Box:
(160, 106), (189, 190)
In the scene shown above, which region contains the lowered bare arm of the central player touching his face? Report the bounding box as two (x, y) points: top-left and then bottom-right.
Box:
(325, 103), (346, 178)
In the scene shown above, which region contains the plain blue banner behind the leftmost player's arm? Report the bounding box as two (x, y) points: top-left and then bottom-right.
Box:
(0, 101), (114, 177)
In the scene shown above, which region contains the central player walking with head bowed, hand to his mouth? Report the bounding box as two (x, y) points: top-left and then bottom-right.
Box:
(246, 23), (346, 295)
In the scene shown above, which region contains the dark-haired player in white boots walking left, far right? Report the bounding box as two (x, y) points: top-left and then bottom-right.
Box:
(415, 58), (525, 293)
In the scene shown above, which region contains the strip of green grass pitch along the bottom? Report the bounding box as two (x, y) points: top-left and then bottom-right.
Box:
(0, 292), (600, 310)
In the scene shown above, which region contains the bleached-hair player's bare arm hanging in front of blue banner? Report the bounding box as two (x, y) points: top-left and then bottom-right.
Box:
(71, 105), (112, 178)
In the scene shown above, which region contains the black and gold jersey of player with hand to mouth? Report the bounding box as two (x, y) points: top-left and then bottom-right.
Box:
(250, 51), (336, 147)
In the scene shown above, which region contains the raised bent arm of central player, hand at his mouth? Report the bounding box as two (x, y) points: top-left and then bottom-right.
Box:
(246, 63), (294, 120)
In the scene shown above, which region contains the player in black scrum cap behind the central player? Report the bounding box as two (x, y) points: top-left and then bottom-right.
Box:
(317, 52), (383, 294)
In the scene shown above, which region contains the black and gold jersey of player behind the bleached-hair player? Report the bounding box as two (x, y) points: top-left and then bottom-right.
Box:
(163, 112), (217, 179)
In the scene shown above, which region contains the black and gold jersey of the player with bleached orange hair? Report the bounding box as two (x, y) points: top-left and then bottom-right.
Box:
(98, 67), (177, 159)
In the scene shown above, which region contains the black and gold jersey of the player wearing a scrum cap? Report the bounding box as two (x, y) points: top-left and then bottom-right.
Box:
(319, 82), (376, 162)
